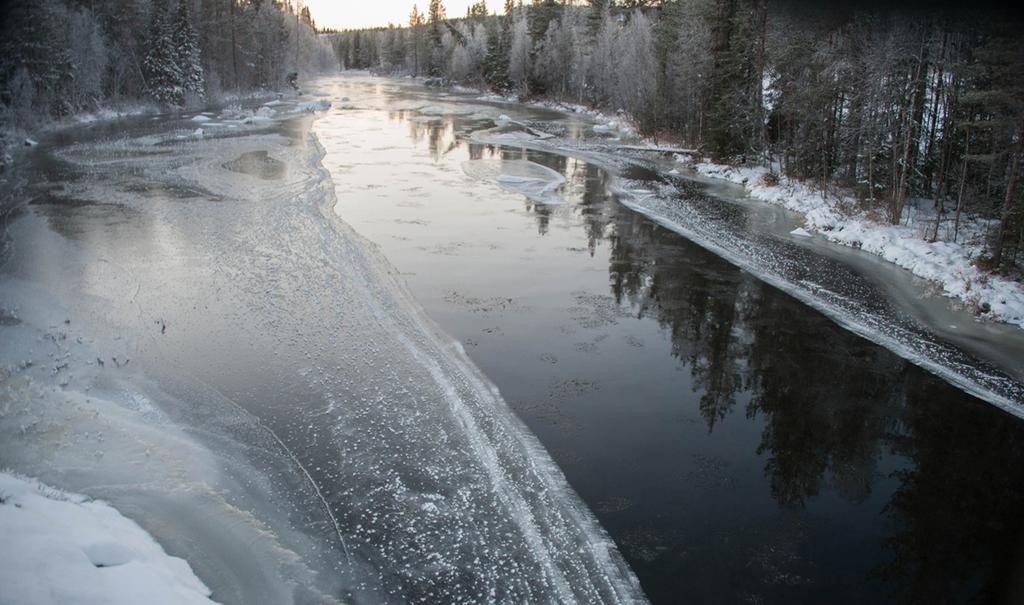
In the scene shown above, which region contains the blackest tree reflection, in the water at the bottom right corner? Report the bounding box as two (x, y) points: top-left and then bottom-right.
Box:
(878, 372), (1024, 605)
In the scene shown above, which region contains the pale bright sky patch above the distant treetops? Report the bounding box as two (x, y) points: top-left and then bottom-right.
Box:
(305, 0), (505, 30)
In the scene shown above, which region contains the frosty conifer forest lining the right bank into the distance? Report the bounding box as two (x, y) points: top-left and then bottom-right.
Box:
(332, 0), (1024, 270)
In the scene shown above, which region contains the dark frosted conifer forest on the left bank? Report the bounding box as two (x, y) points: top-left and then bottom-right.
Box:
(0, 0), (338, 127)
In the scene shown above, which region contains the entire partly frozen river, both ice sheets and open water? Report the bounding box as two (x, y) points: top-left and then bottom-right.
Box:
(0, 76), (1024, 603)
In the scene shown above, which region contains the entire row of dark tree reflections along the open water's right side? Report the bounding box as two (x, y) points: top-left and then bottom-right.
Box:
(516, 163), (1024, 603)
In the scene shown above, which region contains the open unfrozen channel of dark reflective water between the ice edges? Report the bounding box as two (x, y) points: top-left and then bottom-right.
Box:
(315, 78), (1024, 603)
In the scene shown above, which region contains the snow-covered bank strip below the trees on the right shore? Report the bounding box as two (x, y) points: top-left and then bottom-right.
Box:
(693, 162), (1024, 328)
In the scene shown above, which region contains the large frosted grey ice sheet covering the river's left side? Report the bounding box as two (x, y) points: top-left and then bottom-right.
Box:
(0, 99), (643, 603)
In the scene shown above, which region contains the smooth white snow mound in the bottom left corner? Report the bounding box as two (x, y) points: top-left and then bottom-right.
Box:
(0, 472), (220, 605)
